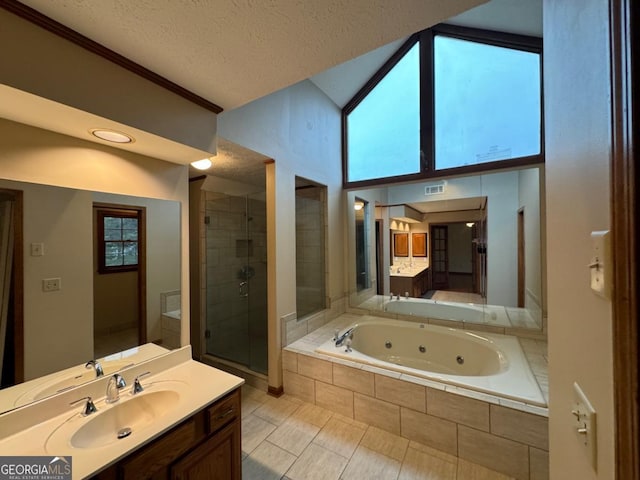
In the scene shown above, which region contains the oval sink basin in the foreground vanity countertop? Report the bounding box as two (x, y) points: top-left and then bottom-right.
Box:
(70, 390), (180, 448)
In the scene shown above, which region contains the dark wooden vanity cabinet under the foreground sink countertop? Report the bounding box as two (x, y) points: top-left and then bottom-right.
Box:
(93, 388), (242, 480)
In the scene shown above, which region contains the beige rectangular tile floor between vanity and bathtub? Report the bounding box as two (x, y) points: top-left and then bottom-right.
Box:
(242, 385), (510, 480)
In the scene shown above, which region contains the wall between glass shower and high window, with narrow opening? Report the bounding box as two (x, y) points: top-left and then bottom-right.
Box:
(218, 81), (346, 387)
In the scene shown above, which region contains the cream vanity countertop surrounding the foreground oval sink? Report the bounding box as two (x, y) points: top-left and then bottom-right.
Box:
(0, 347), (244, 479)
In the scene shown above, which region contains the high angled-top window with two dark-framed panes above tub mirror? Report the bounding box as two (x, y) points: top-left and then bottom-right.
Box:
(343, 25), (544, 187)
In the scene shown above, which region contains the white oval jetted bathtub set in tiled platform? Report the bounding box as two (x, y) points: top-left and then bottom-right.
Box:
(316, 319), (547, 407)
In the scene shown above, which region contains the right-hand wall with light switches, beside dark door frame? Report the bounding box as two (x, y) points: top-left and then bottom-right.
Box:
(543, 0), (623, 480)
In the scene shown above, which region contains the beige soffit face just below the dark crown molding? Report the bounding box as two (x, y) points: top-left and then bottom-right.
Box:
(0, 9), (216, 153)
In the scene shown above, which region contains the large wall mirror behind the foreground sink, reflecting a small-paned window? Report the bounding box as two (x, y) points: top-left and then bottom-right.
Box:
(0, 179), (181, 411)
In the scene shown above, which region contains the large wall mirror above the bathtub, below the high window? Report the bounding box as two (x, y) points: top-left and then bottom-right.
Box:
(347, 167), (546, 331)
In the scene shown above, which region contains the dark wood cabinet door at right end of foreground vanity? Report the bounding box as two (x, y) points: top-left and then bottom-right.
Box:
(169, 421), (242, 480)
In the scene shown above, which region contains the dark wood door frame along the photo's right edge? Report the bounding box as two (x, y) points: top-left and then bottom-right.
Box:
(609, 0), (640, 480)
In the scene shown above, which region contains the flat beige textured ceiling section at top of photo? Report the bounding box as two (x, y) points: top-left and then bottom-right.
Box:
(21, 0), (486, 109)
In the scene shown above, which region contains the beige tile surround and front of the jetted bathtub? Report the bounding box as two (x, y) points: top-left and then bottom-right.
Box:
(283, 314), (548, 480)
